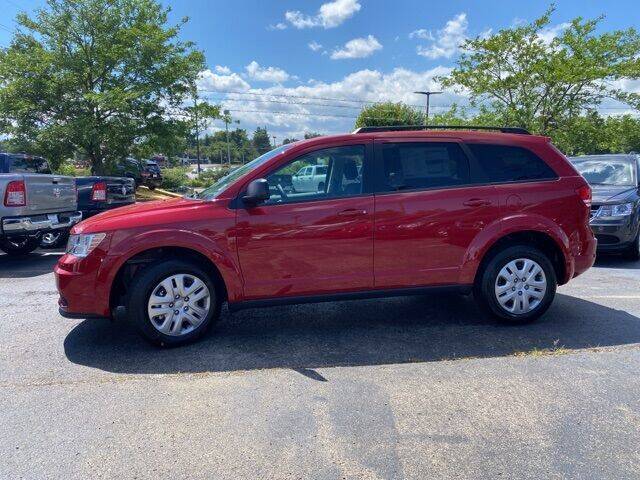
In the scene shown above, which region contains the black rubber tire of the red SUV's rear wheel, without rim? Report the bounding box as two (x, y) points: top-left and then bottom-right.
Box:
(474, 245), (558, 325)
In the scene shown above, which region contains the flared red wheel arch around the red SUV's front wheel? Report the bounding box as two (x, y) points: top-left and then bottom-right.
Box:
(96, 228), (242, 314)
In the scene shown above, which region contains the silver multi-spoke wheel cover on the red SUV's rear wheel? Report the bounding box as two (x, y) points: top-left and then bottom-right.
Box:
(495, 258), (547, 315)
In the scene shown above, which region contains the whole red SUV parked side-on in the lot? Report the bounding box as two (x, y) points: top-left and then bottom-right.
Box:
(55, 127), (596, 345)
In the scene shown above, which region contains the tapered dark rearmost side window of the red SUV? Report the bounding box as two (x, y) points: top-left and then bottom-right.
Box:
(467, 143), (558, 183)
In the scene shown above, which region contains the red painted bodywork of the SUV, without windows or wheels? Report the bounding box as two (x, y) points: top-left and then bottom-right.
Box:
(55, 131), (595, 316)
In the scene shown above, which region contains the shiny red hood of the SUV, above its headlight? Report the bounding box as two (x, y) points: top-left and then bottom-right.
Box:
(71, 198), (218, 233)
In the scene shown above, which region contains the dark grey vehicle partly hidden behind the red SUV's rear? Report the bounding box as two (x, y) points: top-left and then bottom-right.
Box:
(569, 154), (640, 260)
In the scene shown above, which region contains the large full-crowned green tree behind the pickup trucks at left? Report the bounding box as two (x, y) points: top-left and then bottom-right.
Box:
(0, 0), (204, 173)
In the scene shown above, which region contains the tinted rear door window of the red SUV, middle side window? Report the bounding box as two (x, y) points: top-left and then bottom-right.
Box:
(378, 142), (470, 192)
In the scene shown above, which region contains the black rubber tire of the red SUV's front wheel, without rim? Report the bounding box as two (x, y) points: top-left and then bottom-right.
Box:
(126, 260), (221, 347)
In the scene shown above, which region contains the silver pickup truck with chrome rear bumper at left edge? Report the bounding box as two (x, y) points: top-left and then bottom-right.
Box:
(0, 153), (82, 255)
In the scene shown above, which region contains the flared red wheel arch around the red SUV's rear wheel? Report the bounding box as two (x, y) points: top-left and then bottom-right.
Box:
(460, 213), (575, 284)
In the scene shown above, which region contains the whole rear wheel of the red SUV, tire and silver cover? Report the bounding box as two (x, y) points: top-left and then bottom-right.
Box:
(475, 245), (557, 324)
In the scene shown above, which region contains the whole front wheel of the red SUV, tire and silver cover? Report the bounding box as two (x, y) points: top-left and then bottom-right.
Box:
(127, 260), (220, 347)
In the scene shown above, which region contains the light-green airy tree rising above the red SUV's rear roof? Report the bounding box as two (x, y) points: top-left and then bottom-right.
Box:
(440, 7), (640, 134)
